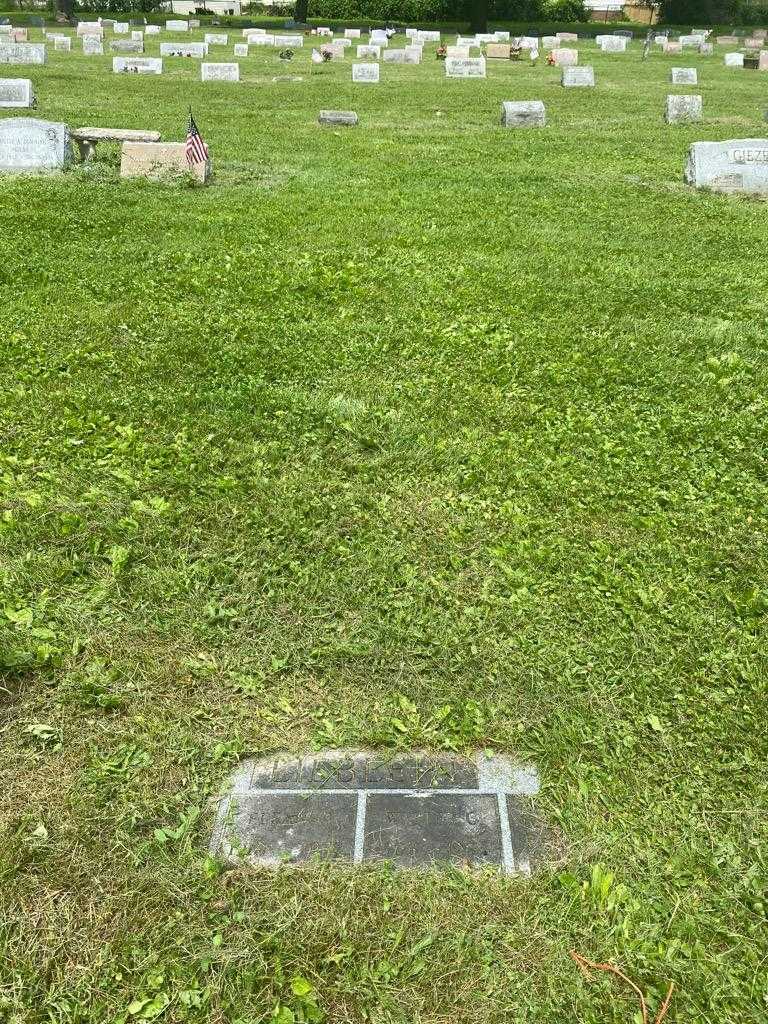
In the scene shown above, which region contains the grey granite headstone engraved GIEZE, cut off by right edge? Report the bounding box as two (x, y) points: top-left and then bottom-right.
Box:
(685, 138), (768, 195)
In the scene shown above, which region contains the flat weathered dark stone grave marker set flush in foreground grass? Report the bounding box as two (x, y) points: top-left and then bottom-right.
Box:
(211, 751), (542, 873)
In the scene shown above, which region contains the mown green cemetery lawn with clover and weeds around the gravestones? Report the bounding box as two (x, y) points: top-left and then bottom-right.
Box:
(0, 32), (768, 1024)
